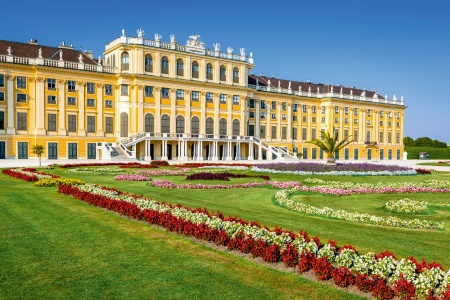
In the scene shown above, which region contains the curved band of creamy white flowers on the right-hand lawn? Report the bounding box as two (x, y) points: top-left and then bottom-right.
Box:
(275, 188), (444, 230)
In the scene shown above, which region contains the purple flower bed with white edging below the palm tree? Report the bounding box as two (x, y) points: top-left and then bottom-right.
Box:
(252, 162), (417, 176)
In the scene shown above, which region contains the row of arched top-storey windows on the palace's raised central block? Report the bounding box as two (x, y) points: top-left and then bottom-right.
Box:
(119, 52), (239, 83)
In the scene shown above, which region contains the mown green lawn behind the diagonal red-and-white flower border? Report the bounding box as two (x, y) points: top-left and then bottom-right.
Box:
(46, 169), (450, 269)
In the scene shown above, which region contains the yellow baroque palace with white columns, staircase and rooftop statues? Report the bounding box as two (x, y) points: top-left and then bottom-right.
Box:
(0, 29), (406, 161)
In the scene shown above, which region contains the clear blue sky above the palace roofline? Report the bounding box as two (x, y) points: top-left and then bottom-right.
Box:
(0, 0), (450, 141)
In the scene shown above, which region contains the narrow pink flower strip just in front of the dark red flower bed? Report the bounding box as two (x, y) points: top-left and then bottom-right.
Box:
(148, 180), (300, 190)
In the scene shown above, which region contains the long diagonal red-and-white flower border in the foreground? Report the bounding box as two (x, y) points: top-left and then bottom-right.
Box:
(58, 185), (450, 299)
